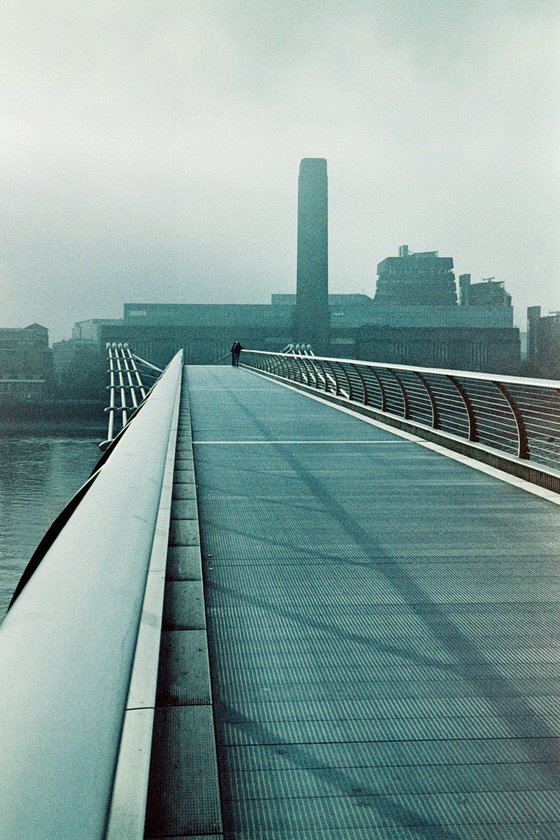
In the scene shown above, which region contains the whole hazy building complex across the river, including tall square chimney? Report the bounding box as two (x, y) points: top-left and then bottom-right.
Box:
(55, 164), (520, 373)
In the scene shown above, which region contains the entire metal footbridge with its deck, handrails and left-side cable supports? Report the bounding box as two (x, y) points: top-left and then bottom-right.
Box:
(0, 346), (560, 840)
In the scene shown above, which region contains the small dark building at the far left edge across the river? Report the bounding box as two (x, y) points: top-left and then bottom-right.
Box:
(0, 324), (53, 403)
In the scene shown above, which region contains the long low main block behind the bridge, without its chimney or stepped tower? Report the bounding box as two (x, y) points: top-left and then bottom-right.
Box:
(84, 278), (520, 374)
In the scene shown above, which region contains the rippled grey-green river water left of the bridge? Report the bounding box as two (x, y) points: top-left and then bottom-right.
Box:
(0, 435), (100, 621)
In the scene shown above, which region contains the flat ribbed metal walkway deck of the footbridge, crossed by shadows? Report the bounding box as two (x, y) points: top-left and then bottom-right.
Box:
(155, 367), (560, 840)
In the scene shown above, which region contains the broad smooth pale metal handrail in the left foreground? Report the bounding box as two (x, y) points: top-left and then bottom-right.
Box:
(0, 353), (182, 840)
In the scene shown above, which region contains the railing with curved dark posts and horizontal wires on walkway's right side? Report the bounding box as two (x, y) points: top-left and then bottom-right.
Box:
(241, 350), (560, 470)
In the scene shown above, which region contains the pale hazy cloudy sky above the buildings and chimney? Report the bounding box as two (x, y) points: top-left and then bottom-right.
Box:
(0, 0), (560, 340)
